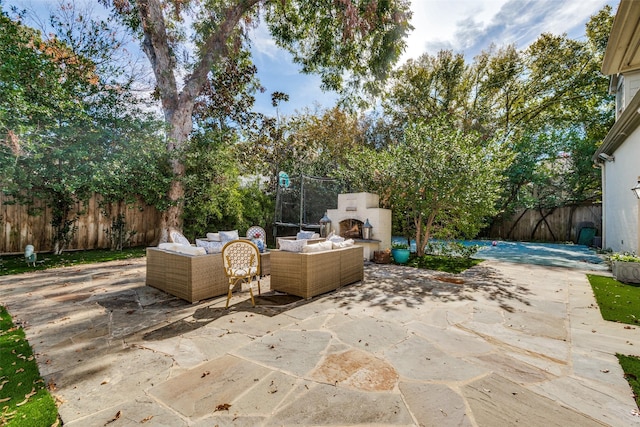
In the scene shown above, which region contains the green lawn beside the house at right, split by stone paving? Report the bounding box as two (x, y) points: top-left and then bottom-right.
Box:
(587, 274), (640, 408)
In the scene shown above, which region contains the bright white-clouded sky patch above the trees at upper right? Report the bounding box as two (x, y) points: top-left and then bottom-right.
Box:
(402, 0), (619, 62)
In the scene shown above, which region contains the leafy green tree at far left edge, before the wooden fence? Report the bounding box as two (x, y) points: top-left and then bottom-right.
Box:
(0, 13), (99, 253)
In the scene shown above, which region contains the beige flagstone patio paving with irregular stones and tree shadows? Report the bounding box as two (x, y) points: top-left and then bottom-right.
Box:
(0, 258), (640, 427)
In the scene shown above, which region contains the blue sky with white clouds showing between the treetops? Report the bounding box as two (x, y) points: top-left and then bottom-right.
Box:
(5, 0), (619, 116)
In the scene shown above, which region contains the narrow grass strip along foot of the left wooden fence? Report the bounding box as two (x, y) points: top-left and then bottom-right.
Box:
(0, 247), (146, 276)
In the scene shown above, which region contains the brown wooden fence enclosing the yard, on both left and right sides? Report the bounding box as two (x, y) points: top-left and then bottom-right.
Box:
(0, 194), (602, 253)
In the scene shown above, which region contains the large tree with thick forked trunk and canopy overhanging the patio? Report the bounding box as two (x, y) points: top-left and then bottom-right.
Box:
(101, 0), (410, 239)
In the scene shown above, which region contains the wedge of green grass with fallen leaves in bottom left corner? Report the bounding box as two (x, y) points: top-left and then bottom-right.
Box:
(0, 305), (58, 427)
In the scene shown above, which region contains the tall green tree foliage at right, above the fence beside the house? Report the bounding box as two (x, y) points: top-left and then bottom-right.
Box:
(378, 6), (613, 224)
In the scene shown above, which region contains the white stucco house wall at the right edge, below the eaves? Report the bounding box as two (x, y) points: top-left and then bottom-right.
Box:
(602, 134), (640, 253)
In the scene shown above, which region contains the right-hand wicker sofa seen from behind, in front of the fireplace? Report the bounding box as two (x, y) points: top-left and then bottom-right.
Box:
(271, 246), (364, 299)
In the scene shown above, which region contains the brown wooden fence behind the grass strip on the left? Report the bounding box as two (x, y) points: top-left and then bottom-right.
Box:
(0, 195), (161, 253)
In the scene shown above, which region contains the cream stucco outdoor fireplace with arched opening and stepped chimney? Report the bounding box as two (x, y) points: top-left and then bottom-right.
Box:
(327, 193), (391, 260)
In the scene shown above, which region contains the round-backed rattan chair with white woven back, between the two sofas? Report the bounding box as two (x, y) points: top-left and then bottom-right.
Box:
(222, 240), (260, 308)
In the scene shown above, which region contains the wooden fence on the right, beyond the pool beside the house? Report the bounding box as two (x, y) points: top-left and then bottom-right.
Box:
(483, 204), (602, 243)
